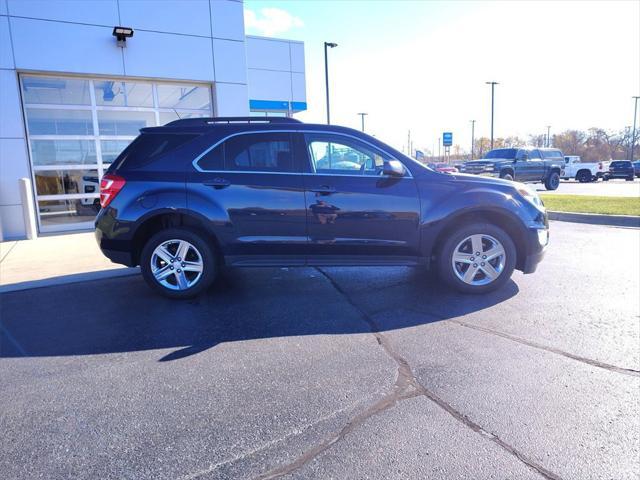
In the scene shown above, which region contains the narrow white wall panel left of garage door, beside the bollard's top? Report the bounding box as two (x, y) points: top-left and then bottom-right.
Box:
(0, 138), (31, 205)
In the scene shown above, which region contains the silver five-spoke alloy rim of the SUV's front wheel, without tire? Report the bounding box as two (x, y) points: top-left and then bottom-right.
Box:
(451, 233), (506, 286)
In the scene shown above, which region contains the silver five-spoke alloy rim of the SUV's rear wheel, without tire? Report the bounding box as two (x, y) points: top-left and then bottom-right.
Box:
(151, 239), (204, 290)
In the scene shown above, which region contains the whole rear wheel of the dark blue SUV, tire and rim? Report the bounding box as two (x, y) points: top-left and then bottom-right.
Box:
(140, 228), (217, 298)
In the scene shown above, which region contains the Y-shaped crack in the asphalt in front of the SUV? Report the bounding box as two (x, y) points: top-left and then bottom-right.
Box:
(256, 267), (562, 480)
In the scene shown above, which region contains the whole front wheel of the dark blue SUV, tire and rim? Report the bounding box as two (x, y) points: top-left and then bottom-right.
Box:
(437, 223), (516, 293)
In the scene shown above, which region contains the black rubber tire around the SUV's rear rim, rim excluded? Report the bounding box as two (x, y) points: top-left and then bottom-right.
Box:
(140, 227), (218, 299)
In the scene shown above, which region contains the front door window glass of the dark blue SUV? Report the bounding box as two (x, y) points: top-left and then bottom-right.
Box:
(305, 135), (388, 175)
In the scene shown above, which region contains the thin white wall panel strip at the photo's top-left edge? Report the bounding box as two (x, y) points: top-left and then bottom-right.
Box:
(9, 0), (118, 26)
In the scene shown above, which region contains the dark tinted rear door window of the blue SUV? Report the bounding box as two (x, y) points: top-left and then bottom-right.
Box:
(198, 133), (294, 172)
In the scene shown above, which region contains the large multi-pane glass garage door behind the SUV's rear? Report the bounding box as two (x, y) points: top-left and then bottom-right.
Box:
(20, 75), (212, 232)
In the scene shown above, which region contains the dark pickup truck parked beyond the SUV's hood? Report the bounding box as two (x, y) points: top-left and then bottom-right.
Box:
(460, 148), (564, 190)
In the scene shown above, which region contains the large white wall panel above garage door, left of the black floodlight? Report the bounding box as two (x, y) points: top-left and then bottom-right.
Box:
(10, 17), (124, 75)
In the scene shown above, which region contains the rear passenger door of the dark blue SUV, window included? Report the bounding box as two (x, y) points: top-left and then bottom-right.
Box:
(187, 131), (307, 265)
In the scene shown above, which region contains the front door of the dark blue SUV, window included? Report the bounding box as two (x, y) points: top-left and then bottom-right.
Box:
(304, 132), (420, 264)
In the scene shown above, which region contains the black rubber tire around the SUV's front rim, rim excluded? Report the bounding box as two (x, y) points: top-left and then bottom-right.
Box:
(436, 223), (516, 294)
